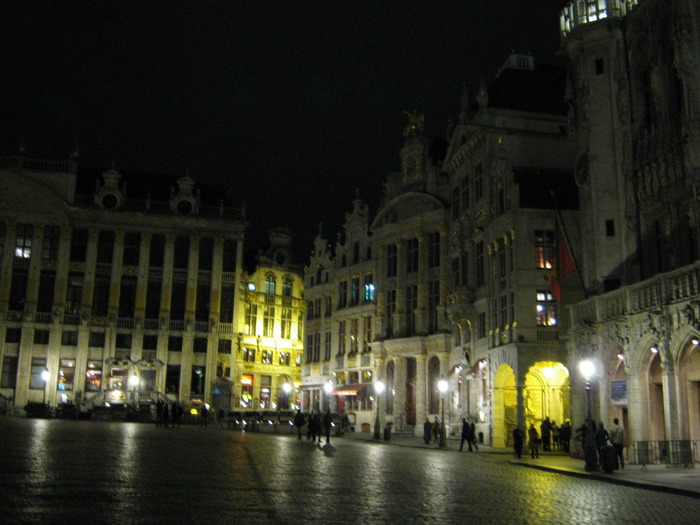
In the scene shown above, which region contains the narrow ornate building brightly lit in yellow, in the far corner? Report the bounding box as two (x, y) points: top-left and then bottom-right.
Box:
(233, 229), (305, 410)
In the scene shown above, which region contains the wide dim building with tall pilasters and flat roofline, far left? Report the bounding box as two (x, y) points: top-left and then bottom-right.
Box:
(0, 156), (246, 415)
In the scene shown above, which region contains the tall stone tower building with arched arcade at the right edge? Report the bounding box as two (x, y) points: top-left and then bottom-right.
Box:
(561, 0), (700, 450)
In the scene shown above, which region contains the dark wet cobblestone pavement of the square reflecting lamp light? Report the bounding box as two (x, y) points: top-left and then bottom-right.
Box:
(0, 417), (700, 525)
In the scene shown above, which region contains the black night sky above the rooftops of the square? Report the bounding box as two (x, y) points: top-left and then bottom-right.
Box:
(0, 0), (566, 260)
